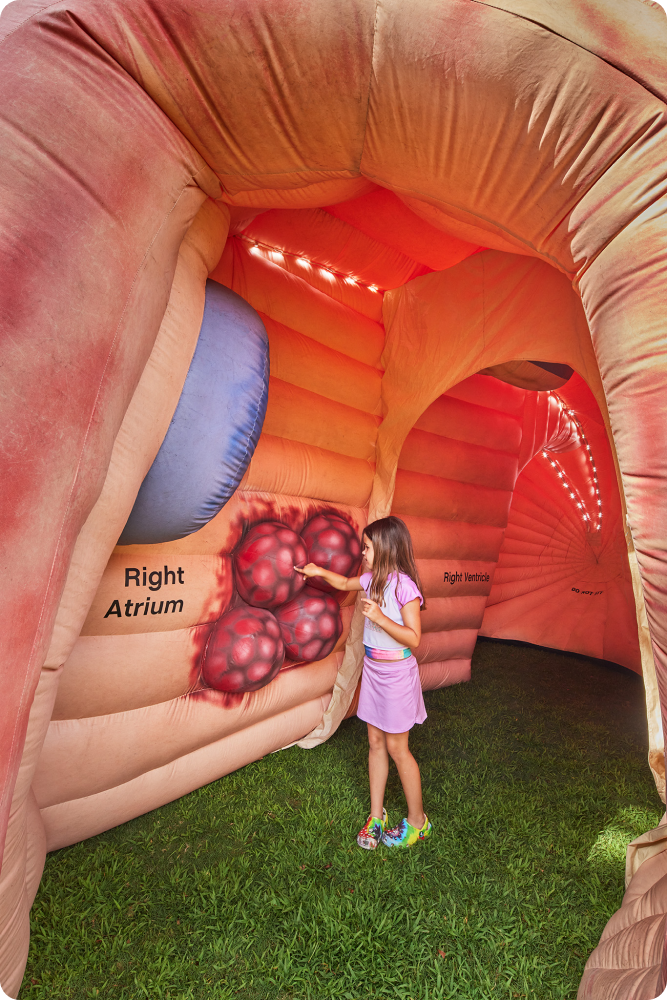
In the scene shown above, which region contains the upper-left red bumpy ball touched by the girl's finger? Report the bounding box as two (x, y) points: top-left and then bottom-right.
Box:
(234, 521), (307, 610)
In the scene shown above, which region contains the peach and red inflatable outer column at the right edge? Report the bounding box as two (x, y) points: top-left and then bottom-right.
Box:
(580, 205), (667, 752)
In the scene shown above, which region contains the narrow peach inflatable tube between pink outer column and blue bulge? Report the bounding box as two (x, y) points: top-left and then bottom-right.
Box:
(0, 201), (228, 996)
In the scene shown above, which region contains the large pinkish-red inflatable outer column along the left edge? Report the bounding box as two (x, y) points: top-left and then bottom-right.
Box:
(0, 0), (220, 884)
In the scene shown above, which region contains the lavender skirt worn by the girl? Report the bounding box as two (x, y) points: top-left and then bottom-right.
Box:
(357, 656), (426, 733)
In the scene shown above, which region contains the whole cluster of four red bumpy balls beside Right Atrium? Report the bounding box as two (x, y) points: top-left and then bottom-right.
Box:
(202, 511), (361, 693)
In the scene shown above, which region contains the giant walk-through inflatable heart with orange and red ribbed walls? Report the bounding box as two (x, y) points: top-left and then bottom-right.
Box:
(0, 0), (667, 1000)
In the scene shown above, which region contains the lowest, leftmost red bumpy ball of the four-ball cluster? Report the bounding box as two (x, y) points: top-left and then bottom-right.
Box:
(202, 605), (285, 694)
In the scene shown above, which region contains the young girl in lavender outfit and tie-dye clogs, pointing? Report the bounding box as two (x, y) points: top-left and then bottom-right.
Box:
(300, 517), (432, 850)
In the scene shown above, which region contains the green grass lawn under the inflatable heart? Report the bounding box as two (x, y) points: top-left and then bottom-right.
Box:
(21, 642), (661, 1000)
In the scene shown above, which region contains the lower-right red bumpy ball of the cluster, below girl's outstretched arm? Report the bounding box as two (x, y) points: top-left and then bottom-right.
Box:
(276, 587), (343, 662)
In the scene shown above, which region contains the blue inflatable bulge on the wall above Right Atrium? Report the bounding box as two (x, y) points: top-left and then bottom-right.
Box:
(118, 281), (269, 545)
